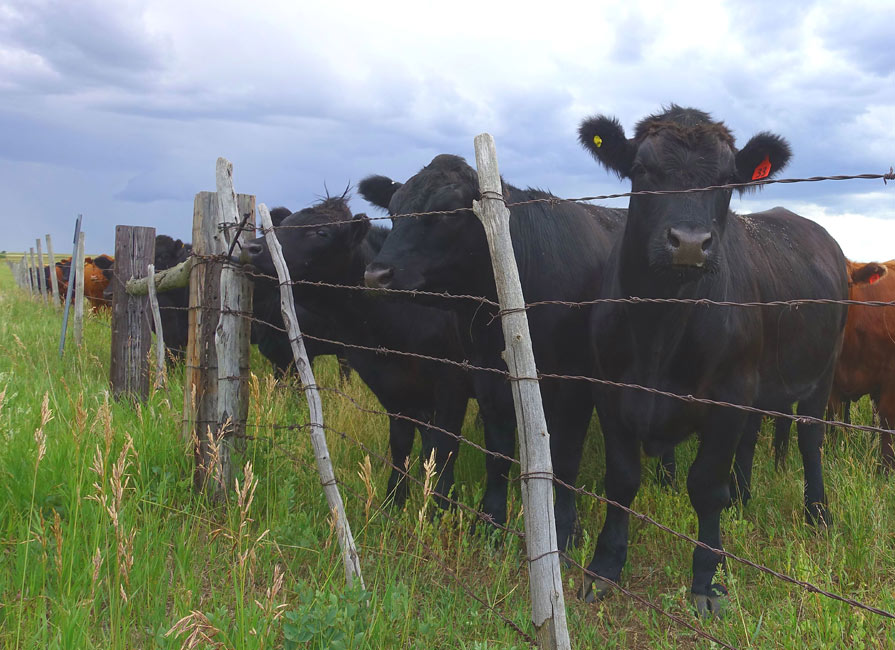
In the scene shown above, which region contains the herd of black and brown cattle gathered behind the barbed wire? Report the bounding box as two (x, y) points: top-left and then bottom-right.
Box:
(42, 105), (895, 615)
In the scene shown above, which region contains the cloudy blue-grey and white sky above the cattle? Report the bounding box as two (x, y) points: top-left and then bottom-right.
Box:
(0, 0), (895, 260)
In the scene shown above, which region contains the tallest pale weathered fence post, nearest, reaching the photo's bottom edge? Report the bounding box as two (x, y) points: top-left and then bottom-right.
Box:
(472, 133), (571, 650)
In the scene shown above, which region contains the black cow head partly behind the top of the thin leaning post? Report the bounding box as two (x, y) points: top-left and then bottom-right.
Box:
(246, 196), (370, 283)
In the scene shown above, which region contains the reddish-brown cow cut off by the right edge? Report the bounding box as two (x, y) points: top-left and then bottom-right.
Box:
(830, 260), (895, 471)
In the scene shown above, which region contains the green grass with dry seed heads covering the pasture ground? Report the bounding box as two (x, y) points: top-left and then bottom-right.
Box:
(0, 265), (895, 650)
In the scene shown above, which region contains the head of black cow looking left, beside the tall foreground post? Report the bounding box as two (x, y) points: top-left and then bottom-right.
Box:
(358, 154), (490, 292)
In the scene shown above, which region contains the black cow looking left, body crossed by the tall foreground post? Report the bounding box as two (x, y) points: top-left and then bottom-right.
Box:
(359, 155), (624, 548)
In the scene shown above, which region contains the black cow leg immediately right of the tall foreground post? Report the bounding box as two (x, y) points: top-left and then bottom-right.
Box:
(544, 380), (594, 551)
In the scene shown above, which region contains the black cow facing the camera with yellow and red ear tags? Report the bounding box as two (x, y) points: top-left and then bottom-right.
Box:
(579, 105), (848, 614)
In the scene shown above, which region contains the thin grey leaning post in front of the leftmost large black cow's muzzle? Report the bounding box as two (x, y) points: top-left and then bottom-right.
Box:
(258, 203), (364, 587)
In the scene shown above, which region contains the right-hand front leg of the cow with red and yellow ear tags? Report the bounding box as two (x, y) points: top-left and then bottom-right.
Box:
(687, 408), (748, 616)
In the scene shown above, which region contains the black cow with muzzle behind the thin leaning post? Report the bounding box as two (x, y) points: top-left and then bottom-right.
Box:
(247, 196), (470, 506)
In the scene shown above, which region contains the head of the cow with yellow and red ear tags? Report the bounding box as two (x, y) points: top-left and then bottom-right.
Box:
(579, 104), (790, 281)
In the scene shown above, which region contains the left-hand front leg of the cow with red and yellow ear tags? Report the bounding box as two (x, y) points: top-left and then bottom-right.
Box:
(579, 409), (640, 603)
